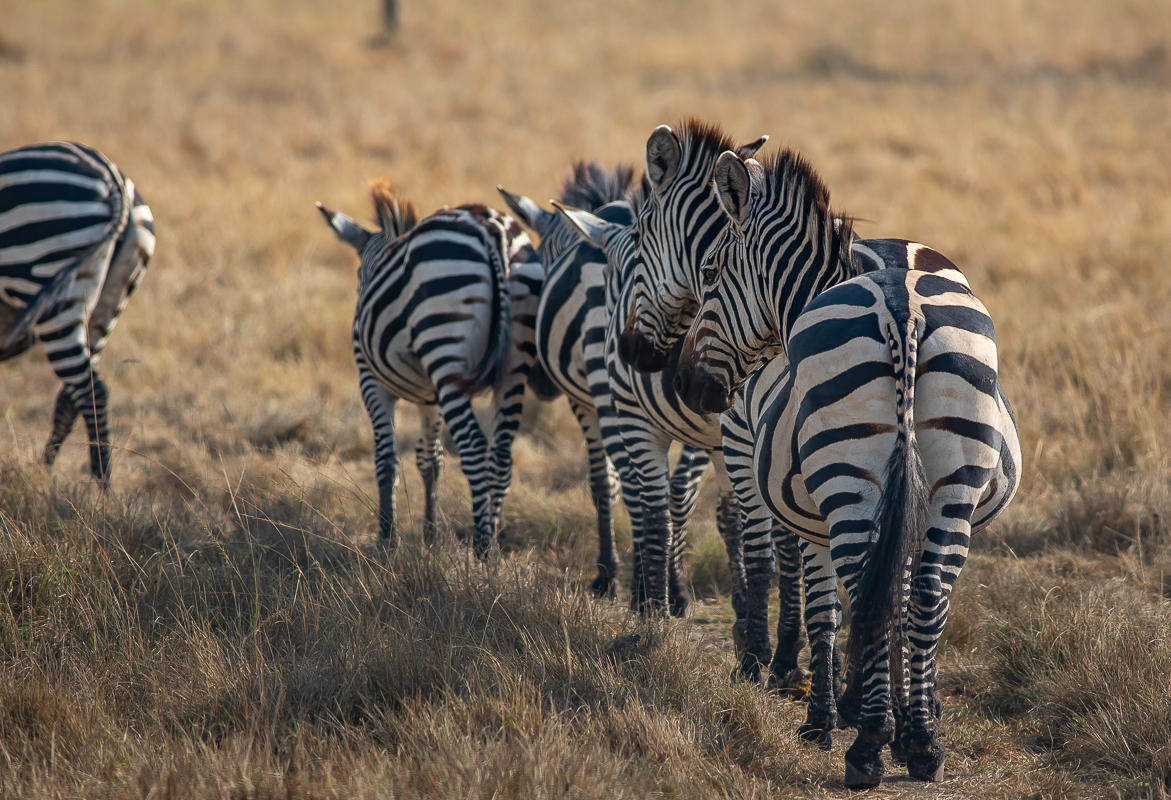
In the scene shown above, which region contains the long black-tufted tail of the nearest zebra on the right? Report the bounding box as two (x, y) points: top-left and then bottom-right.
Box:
(848, 319), (931, 702)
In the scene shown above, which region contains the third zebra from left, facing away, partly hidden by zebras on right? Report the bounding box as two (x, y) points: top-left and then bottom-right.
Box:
(497, 162), (711, 614)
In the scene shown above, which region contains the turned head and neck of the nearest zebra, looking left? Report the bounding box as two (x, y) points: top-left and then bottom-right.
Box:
(674, 150), (857, 413)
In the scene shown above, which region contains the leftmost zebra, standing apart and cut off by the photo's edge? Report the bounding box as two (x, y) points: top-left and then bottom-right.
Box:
(0, 142), (155, 490)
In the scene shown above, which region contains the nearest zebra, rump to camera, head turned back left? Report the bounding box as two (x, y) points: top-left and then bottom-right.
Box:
(677, 150), (1021, 788)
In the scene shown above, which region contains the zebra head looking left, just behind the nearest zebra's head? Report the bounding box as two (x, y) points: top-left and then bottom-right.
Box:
(618, 119), (768, 372)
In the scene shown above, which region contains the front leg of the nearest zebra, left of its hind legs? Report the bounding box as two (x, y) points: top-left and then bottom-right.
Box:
(797, 540), (840, 750)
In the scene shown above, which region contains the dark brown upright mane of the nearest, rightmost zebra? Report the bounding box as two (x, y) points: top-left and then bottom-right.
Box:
(753, 148), (862, 278)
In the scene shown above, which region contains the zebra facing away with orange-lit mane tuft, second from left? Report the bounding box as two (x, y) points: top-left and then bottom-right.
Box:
(317, 180), (543, 558)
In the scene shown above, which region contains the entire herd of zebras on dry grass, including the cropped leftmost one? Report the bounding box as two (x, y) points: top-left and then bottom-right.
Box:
(0, 119), (1021, 788)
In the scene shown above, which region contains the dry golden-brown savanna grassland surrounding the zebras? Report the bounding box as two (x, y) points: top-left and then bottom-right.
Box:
(0, 0), (1171, 798)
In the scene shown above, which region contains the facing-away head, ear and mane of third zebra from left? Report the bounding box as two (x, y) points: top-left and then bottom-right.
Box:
(497, 162), (637, 266)
